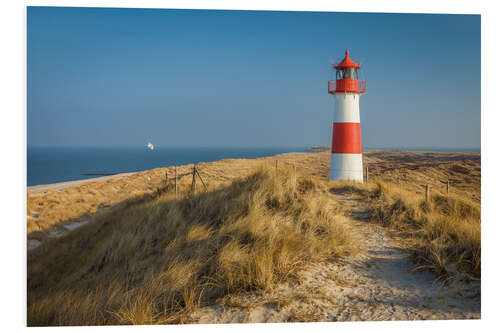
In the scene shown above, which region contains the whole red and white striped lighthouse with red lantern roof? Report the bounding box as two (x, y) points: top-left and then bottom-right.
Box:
(328, 50), (366, 182)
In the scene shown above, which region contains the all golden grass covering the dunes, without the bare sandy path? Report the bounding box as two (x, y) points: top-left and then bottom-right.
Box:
(27, 151), (481, 326)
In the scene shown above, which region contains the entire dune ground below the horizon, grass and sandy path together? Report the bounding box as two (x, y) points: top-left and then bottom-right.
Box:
(27, 151), (481, 326)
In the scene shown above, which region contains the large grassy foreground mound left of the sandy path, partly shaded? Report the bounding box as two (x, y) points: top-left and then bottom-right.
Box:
(28, 167), (357, 326)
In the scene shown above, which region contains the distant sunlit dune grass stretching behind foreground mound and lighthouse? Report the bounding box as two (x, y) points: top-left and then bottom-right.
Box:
(27, 150), (481, 240)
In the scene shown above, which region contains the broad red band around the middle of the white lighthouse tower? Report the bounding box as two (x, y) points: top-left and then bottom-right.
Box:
(332, 123), (361, 154)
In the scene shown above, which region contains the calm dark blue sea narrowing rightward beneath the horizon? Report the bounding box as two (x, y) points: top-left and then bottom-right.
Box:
(27, 147), (306, 186)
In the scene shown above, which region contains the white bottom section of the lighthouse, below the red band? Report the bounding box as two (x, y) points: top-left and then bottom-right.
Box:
(330, 153), (363, 183)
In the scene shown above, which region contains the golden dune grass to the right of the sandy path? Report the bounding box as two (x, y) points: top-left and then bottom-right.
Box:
(332, 181), (481, 280)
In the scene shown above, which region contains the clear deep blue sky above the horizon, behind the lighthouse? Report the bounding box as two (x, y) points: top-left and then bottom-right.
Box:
(27, 7), (481, 148)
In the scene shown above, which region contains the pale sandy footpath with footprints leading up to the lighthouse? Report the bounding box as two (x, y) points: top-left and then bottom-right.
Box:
(192, 196), (481, 323)
